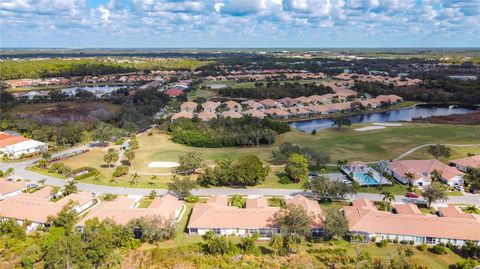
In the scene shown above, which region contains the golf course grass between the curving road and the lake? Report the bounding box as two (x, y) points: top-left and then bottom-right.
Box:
(52, 123), (480, 188)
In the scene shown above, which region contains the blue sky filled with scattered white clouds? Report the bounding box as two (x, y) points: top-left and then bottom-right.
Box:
(0, 0), (480, 48)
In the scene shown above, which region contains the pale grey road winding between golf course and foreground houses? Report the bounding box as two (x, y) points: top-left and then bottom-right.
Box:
(0, 144), (480, 207)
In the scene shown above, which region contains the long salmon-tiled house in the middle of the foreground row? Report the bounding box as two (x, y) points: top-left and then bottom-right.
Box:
(187, 195), (323, 238)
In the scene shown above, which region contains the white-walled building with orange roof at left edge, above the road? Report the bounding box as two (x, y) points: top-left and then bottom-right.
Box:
(0, 132), (48, 159)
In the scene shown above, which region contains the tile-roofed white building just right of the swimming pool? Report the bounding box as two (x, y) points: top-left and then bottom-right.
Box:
(388, 159), (464, 186)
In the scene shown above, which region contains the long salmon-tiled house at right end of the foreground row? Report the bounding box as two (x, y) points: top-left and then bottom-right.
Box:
(343, 197), (480, 246)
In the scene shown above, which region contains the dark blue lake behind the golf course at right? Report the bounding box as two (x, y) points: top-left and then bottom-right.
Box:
(290, 104), (479, 132)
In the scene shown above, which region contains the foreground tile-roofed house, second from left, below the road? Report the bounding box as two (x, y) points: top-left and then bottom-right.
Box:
(77, 194), (183, 227)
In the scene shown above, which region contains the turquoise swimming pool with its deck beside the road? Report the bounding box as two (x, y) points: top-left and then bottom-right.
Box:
(340, 161), (392, 186)
